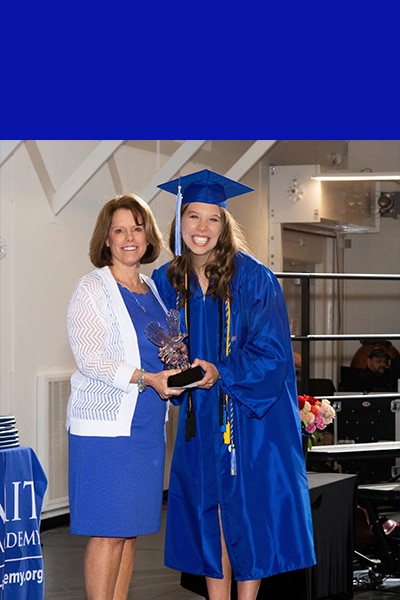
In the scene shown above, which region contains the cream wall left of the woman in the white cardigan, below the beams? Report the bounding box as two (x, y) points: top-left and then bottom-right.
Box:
(0, 146), (98, 448)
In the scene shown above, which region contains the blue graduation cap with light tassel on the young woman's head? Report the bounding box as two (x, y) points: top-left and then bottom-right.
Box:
(157, 169), (253, 256)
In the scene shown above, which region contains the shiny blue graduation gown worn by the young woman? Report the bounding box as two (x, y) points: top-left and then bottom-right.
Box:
(153, 252), (315, 581)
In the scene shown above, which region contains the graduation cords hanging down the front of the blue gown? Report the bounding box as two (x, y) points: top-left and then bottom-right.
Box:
(182, 273), (236, 475)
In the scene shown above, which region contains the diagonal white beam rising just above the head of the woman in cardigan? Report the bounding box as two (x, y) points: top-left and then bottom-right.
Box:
(53, 140), (125, 215)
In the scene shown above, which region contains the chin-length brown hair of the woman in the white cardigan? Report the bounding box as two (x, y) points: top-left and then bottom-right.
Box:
(89, 194), (163, 267)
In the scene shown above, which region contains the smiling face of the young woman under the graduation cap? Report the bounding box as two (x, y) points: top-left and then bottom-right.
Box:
(182, 202), (222, 259)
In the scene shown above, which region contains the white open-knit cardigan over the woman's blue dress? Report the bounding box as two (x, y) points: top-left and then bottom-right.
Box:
(66, 267), (166, 437)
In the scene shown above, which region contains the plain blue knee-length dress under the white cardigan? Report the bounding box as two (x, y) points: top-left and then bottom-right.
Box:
(69, 286), (167, 537)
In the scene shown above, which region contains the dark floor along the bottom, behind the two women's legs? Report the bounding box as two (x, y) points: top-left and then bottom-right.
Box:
(41, 511), (400, 600)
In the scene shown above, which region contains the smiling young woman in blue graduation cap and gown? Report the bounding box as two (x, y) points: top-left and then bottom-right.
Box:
(153, 170), (315, 600)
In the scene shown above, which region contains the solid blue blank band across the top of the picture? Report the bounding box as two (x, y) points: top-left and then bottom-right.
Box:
(0, 2), (400, 139)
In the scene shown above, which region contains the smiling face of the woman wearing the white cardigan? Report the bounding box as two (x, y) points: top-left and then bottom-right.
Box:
(106, 208), (147, 266)
